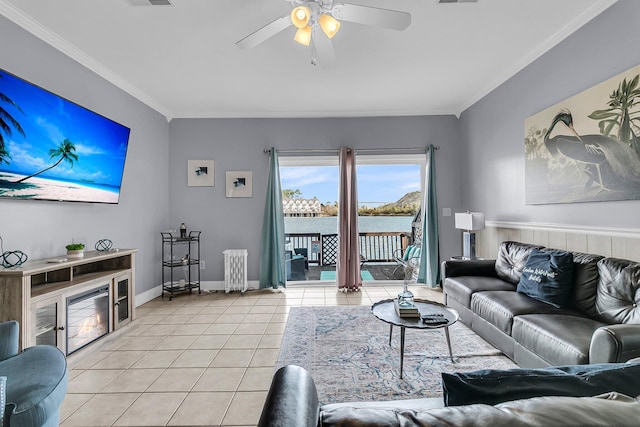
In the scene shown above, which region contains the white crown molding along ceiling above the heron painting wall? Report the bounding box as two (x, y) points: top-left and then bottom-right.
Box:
(455, 0), (618, 117)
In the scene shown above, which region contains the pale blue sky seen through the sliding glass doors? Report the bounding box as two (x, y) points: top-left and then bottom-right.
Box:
(280, 164), (420, 206)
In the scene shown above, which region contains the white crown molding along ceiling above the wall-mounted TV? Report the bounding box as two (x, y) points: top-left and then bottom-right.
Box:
(0, 0), (171, 121)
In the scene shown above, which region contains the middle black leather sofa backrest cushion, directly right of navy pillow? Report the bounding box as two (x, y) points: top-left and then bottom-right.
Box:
(569, 252), (603, 317)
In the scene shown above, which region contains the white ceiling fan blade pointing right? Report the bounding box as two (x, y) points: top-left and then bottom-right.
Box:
(331, 3), (411, 31)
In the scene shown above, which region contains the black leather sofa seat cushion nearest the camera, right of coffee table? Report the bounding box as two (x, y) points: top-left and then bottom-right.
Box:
(511, 314), (604, 365)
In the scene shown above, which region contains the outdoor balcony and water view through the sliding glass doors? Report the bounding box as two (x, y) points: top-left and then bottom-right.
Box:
(280, 158), (421, 283)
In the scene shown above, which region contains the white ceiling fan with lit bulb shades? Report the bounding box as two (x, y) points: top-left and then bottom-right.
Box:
(236, 0), (411, 65)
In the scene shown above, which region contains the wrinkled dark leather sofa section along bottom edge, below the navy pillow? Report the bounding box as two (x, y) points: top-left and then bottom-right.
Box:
(318, 393), (640, 427)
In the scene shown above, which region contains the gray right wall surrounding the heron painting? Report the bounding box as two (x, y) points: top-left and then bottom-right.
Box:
(460, 0), (640, 228)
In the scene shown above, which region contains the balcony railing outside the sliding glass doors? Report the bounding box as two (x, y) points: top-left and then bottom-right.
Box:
(285, 231), (411, 265)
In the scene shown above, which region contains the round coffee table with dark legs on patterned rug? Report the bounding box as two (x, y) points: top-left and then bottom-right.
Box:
(371, 299), (458, 378)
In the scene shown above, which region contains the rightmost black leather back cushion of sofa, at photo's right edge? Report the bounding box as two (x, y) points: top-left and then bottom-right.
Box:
(596, 258), (640, 324)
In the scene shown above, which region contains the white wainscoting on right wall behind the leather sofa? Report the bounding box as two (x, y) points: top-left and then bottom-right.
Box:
(476, 221), (640, 262)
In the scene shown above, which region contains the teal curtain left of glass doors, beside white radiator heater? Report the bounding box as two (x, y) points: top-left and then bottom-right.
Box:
(260, 148), (286, 289)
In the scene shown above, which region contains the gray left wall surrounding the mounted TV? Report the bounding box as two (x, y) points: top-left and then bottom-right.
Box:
(0, 17), (169, 293)
